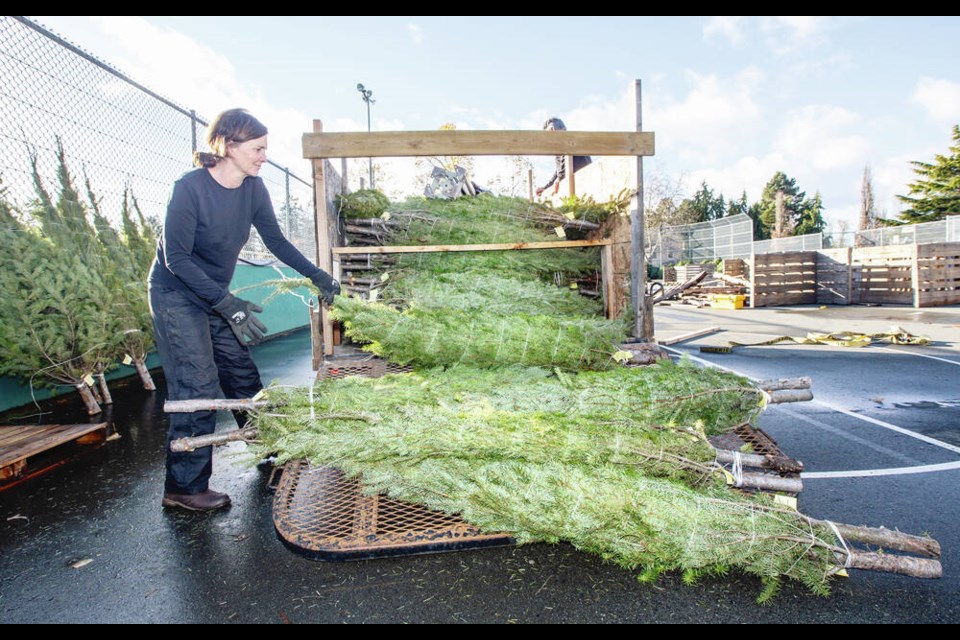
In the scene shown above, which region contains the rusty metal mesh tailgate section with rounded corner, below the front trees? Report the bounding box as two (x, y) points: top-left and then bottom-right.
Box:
(273, 460), (514, 560)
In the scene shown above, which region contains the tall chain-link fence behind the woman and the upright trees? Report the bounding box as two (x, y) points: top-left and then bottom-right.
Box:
(0, 16), (316, 262)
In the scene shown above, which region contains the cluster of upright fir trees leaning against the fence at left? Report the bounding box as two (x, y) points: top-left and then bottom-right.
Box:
(0, 139), (159, 414)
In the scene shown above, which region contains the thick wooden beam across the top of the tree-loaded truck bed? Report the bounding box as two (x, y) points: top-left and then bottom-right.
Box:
(303, 131), (654, 159)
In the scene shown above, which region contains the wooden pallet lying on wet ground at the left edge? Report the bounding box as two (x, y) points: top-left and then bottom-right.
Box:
(0, 422), (107, 490)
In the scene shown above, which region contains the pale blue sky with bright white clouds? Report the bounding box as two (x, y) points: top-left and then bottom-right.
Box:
(32, 16), (960, 230)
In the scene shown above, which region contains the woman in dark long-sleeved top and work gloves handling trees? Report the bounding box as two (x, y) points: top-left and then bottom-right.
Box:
(149, 109), (340, 511)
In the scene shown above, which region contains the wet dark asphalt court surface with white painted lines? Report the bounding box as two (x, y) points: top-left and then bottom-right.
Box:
(0, 308), (960, 624)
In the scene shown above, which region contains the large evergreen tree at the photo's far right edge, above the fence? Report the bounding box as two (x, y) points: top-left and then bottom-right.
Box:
(897, 125), (960, 223)
